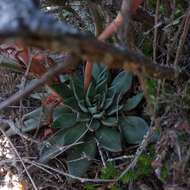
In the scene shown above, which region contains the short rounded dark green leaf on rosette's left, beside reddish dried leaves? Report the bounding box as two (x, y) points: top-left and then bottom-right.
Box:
(52, 106), (78, 128)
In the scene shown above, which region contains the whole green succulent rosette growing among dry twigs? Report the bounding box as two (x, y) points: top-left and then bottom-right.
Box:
(40, 64), (148, 176)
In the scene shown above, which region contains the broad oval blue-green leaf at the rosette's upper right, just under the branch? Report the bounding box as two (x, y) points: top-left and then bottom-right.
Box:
(111, 71), (133, 94)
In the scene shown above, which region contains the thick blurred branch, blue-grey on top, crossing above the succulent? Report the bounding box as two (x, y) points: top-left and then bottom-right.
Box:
(0, 0), (186, 87)
